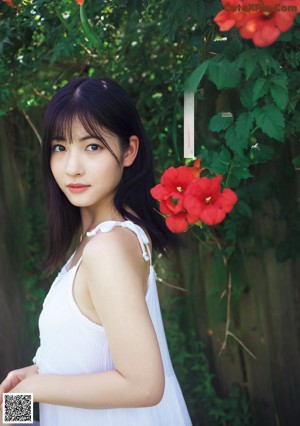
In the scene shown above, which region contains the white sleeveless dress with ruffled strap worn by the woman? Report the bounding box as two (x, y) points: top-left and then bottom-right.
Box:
(33, 220), (192, 426)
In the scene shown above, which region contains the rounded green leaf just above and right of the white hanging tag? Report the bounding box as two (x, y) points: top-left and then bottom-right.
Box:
(208, 59), (241, 90)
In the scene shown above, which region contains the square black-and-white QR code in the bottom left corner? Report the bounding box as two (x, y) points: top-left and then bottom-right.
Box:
(2, 393), (33, 424)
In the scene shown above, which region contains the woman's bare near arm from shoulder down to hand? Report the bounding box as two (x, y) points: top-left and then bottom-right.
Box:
(8, 229), (164, 408)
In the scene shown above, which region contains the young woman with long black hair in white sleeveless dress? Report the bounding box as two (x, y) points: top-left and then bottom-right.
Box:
(0, 77), (191, 426)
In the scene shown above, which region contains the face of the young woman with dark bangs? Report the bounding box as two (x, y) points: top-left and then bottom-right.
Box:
(50, 119), (123, 214)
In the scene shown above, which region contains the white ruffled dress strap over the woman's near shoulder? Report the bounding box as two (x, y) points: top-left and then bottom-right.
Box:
(86, 220), (152, 266)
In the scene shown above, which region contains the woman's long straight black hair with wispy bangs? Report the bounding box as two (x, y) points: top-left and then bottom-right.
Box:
(42, 77), (181, 271)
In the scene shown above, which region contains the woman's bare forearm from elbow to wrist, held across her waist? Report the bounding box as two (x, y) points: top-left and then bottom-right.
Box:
(11, 370), (162, 408)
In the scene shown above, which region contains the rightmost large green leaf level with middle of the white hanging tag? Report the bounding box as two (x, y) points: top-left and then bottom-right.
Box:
(252, 104), (284, 142)
